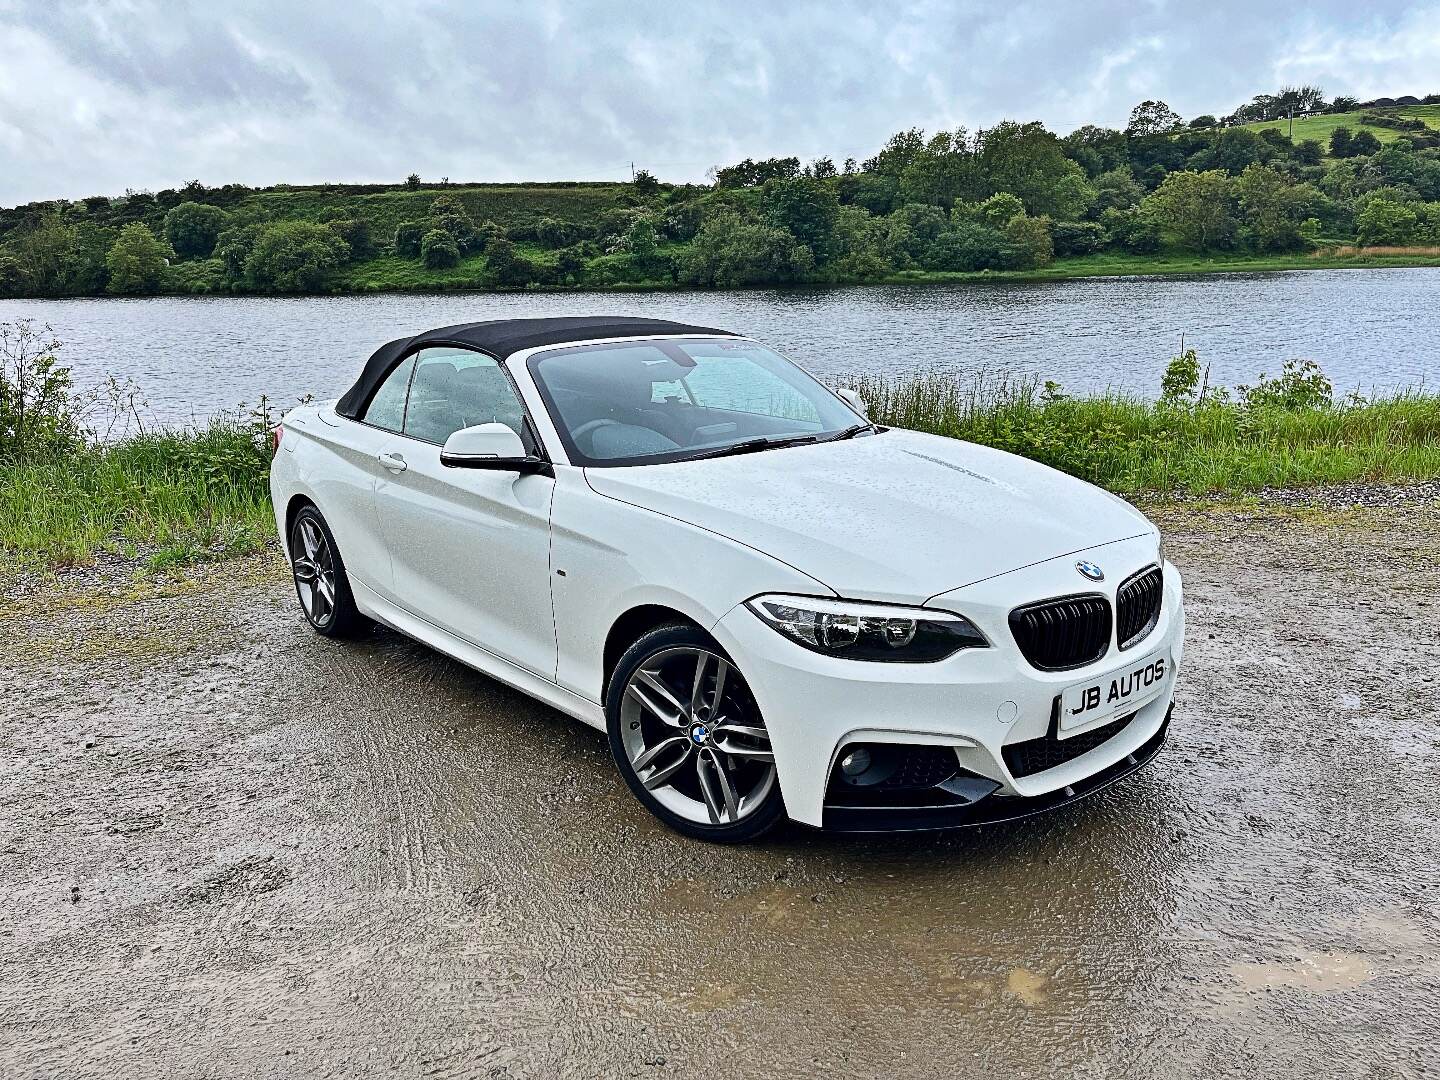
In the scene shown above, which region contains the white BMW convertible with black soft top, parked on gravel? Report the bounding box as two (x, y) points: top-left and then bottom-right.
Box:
(271, 315), (1185, 842)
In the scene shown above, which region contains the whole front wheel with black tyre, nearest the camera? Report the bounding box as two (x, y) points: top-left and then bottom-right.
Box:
(605, 624), (785, 844)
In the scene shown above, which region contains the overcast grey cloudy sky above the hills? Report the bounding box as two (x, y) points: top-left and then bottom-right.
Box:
(0, 0), (1440, 206)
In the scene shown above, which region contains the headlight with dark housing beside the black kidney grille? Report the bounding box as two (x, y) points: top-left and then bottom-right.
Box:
(747, 595), (989, 664)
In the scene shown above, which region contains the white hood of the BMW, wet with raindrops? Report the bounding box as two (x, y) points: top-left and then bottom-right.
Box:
(586, 431), (1153, 603)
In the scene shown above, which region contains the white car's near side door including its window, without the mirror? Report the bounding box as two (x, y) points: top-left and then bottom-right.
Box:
(374, 348), (556, 680)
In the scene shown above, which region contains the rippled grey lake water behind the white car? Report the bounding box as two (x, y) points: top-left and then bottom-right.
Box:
(0, 268), (1440, 423)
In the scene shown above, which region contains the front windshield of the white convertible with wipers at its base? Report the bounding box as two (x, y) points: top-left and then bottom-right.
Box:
(530, 338), (864, 465)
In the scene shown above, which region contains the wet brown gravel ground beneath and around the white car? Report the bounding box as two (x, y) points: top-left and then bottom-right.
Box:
(0, 495), (1440, 1079)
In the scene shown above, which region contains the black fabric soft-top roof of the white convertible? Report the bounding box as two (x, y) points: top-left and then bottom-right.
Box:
(336, 315), (734, 419)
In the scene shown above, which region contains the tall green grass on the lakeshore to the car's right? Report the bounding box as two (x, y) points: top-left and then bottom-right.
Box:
(857, 374), (1440, 494)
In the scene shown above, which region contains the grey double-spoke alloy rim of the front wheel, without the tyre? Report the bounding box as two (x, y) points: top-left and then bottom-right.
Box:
(621, 647), (775, 825)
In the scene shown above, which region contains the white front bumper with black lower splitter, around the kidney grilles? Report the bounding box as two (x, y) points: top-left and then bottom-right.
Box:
(713, 540), (1185, 831)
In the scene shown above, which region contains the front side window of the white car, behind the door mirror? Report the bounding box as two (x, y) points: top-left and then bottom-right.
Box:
(405, 348), (530, 448)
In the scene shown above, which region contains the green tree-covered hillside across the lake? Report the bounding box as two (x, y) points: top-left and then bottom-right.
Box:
(0, 88), (1440, 295)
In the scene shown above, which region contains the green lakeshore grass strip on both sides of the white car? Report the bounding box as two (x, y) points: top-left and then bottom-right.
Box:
(0, 374), (1440, 577)
